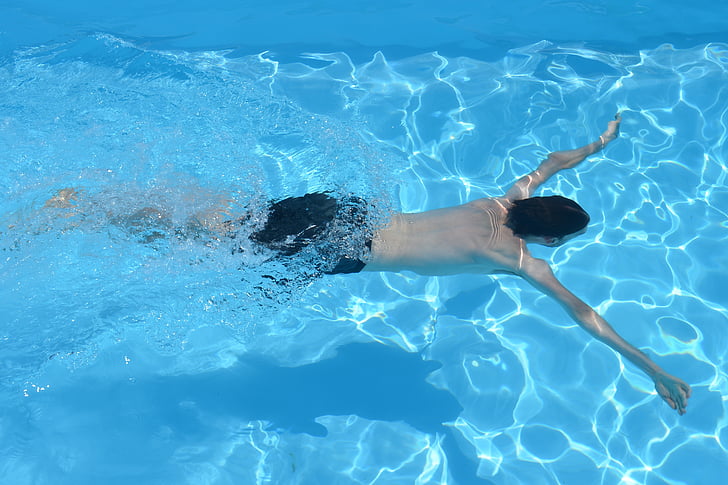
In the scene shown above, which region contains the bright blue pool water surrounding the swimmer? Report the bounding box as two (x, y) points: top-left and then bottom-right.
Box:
(0, 0), (728, 485)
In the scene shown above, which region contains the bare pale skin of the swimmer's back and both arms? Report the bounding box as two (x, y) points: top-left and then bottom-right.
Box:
(363, 115), (691, 415)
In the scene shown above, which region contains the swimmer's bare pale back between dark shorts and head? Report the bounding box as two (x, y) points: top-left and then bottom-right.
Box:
(364, 198), (525, 275)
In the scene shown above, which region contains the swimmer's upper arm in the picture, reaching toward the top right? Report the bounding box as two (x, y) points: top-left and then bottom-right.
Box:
(505, 113), (622, 200)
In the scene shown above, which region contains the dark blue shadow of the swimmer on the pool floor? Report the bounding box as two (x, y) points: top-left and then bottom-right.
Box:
(31, 343), (490, 485)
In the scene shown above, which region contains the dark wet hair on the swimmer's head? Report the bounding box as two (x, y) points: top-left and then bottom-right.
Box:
(506, 195), (589, 238)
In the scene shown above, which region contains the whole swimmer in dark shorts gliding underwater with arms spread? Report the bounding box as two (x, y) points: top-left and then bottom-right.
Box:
(41, 115), (691, 414)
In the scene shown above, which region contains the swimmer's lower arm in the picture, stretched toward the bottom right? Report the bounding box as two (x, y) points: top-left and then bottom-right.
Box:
(520, 257), (691, 415)
